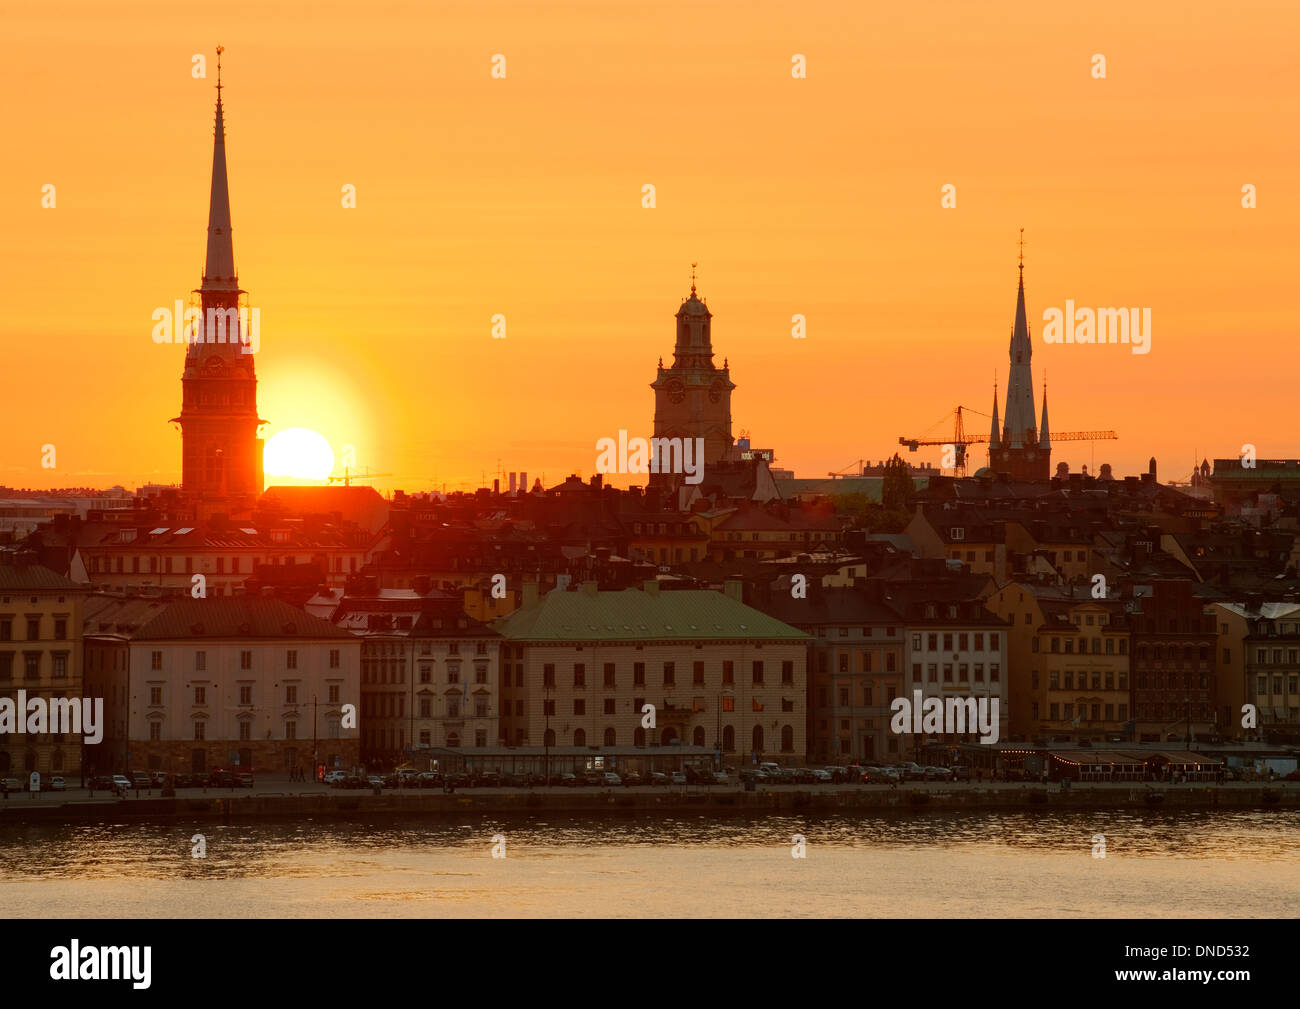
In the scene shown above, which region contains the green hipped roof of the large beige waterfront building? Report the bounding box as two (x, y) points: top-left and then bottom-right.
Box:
(493, 589), (809, 641)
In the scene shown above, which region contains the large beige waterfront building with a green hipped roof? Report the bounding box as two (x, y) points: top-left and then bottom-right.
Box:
(495, 583), (809, 766)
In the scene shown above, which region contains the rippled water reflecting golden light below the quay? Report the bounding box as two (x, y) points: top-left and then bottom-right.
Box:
(0, 810), (1300, 918)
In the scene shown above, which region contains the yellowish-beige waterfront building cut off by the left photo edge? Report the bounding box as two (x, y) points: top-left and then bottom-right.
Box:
(0, 564), (87, 785)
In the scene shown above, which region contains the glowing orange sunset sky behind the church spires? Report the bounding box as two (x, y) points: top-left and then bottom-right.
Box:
(0, 0), (1300, 490)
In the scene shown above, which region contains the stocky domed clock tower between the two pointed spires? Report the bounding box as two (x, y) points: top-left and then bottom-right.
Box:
(650, 270), (736, 478)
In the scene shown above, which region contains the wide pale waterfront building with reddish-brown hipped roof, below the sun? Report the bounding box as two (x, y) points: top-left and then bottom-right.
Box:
(86, 597), (361, 774)
